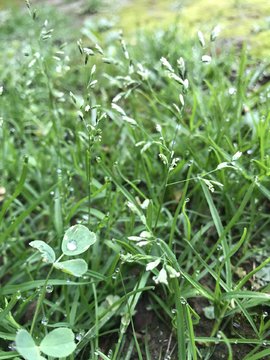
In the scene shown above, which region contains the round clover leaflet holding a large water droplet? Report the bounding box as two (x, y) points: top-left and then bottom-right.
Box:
(62, 225), (96, 256)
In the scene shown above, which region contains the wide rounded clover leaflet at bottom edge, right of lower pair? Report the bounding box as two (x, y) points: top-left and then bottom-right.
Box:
(40, 328), (76, 358)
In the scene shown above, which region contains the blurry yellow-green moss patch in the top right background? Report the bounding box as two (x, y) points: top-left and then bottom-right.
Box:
(120, 0), (270, 58)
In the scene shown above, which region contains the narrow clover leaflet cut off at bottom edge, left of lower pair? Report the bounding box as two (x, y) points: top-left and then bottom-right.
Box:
(15, 330), (40, 360)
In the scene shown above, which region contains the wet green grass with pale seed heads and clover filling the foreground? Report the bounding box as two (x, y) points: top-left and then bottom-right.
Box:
(0, 2), (270, 360)
